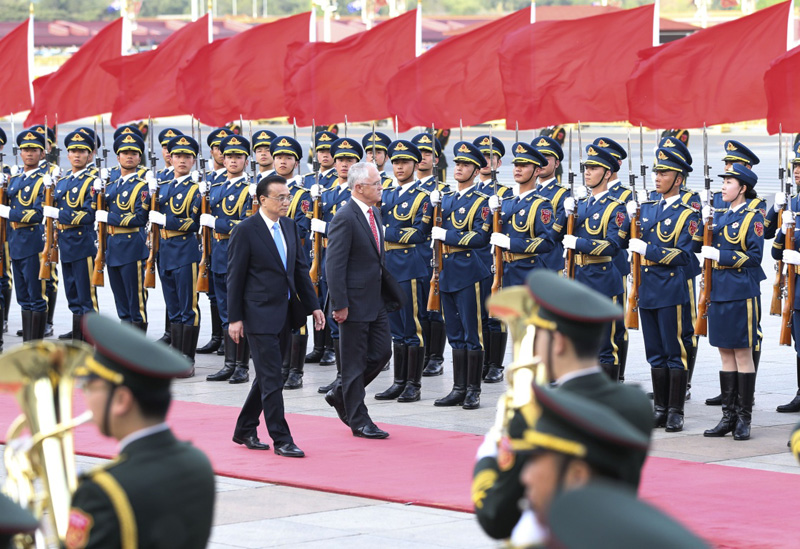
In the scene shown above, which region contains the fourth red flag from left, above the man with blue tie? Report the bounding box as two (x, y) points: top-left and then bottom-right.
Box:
(178, 12), (311, 126)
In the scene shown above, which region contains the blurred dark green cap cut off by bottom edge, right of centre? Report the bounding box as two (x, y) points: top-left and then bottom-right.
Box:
(548, 482), (708, 549)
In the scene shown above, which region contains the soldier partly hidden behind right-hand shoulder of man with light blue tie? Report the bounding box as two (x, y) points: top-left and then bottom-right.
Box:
(270, 132), (310, 389)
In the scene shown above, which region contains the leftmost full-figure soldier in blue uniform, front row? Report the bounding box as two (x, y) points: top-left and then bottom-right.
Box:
(0, 130), (47, 341)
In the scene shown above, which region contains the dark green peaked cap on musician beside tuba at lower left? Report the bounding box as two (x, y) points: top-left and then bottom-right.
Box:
(75, 314), (191, 390)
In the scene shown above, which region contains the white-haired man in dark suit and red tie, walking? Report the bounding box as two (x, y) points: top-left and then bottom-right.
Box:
(325, 162), (402, 438)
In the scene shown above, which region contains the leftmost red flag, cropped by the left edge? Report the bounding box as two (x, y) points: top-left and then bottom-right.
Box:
(0, 17), (33, 115)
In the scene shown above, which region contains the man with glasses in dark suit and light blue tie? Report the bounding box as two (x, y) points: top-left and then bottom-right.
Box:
(228, 175), (325, 457)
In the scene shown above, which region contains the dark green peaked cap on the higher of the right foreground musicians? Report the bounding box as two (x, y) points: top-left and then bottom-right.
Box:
(526, 269), (624, 338)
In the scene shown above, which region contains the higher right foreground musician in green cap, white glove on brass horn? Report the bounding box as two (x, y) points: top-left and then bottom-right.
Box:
(472, 269), (653, 539)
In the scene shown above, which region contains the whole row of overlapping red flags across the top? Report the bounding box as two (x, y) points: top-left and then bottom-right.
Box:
(0, 1), (800, 133)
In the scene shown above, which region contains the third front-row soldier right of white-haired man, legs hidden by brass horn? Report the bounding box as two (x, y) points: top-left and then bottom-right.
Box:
(489, 142), (555, 284)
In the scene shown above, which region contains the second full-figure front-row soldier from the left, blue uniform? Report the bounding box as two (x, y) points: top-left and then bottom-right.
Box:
(44, 131), (97, 340)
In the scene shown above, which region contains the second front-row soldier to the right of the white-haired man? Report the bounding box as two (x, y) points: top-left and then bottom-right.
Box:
(430, 141), (491, 410)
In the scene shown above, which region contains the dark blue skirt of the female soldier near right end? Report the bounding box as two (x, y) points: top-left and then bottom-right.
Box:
(708, 297), (758, 349)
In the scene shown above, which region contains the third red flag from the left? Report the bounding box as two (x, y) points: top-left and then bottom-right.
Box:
(100, 14), (211, 126)
